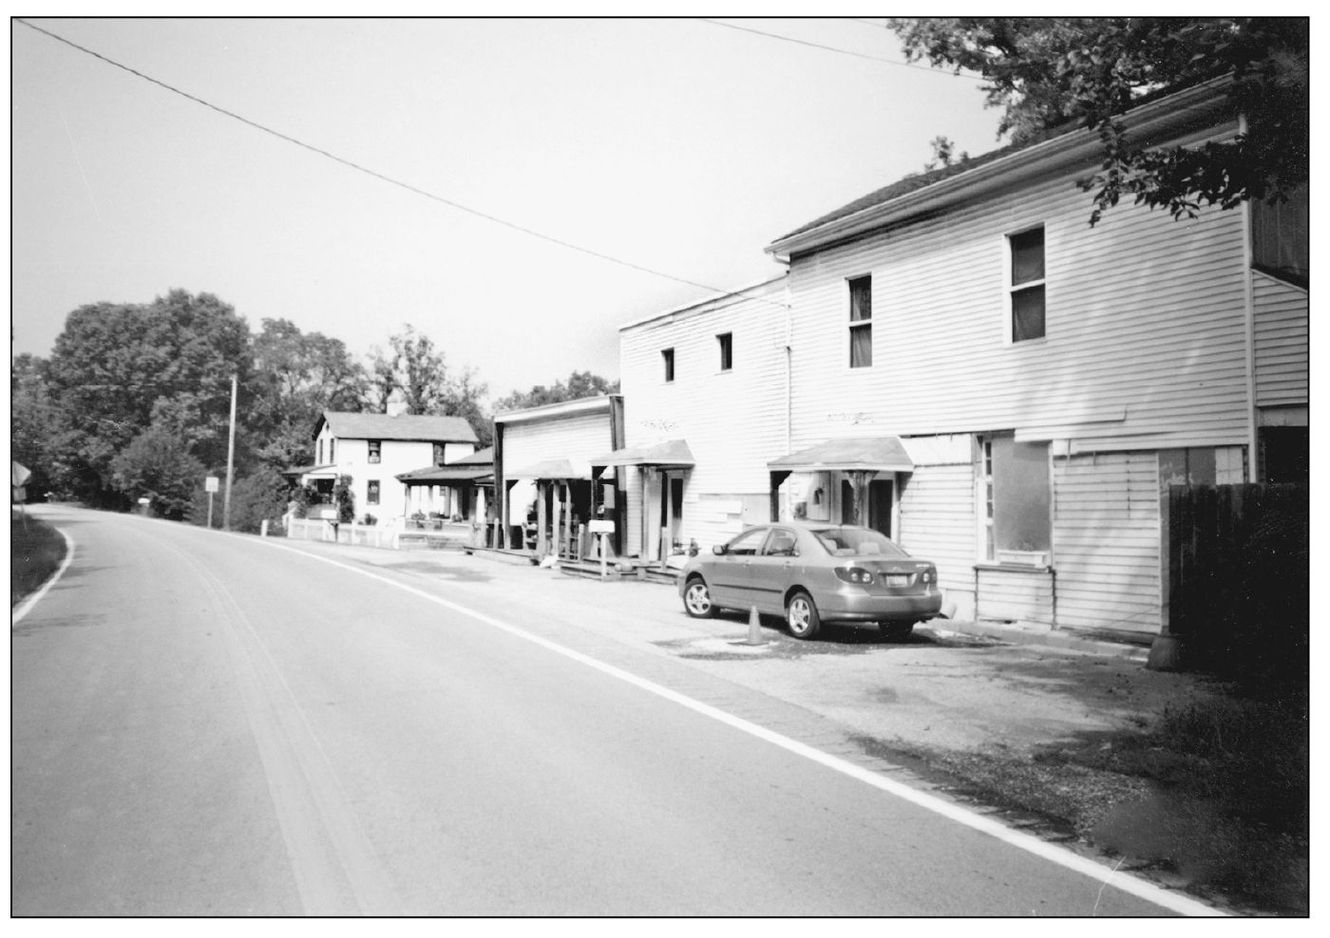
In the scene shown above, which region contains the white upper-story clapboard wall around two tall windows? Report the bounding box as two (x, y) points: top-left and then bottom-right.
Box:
(789, 170), (1248, 451)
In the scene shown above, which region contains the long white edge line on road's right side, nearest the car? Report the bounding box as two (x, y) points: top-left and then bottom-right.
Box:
(251, 540), (1225, 915)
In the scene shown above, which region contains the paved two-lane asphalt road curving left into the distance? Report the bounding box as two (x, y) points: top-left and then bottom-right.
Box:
(12, 507), (1212, 915)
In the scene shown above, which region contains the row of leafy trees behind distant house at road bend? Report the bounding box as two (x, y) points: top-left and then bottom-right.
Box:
(11, 290), (618, 530)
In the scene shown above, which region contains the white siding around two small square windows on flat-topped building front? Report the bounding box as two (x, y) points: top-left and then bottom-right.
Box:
(620, 277), (787, 551)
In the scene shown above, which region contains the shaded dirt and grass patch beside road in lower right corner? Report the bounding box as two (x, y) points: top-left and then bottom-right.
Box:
(857, 657), (1310, 915)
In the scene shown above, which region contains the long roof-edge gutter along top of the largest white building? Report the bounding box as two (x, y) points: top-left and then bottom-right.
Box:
(766, 76), (1232, 259)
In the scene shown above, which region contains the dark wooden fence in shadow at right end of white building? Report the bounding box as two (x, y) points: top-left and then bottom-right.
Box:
(1169, 486), (1309, 672)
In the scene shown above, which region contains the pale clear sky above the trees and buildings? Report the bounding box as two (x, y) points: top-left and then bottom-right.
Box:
(11, 17), (1001, 399)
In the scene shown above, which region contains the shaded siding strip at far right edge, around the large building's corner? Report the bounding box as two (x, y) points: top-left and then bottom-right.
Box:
(1252, 271), (1309, 407)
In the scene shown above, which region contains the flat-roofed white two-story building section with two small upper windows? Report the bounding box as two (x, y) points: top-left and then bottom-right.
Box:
(614, 273), (790, 561)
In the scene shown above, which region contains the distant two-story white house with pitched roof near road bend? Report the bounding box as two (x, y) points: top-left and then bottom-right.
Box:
(301, 411), (476, 522)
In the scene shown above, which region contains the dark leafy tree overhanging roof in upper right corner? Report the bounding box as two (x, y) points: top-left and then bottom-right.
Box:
(891, 17), (1310, 225)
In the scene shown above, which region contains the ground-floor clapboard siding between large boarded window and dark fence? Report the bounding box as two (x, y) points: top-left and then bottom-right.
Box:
(1053, 452), (1164, 633)
